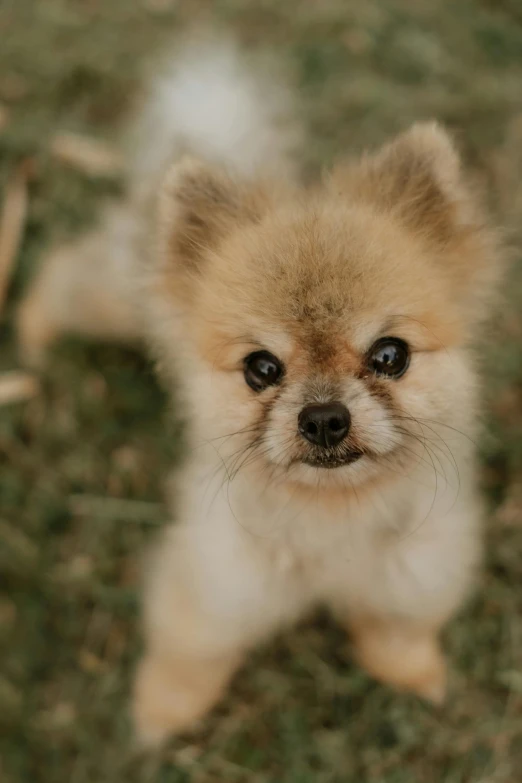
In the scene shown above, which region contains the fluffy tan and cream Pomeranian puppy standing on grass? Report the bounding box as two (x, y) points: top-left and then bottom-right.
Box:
(21, 36), (500, 742)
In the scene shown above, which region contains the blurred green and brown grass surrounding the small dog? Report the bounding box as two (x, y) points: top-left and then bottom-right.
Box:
(0, 0), (522, 783)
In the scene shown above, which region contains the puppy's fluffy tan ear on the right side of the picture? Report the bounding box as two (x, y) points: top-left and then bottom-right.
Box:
(331, 122), (501, 304)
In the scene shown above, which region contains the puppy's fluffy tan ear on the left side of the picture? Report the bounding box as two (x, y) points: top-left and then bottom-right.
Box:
(159, 158), (264, 274)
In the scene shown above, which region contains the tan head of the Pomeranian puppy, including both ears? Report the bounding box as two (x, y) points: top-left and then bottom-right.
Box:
(152, 126), (493, 489)
